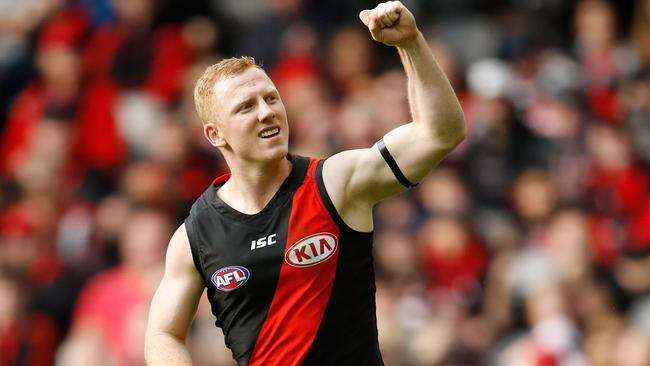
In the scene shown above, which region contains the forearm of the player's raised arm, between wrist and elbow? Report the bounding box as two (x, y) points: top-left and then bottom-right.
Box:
(397, 32), (465, 147)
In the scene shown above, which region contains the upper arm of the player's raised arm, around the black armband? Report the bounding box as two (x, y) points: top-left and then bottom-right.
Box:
(323, 122), (458, 230)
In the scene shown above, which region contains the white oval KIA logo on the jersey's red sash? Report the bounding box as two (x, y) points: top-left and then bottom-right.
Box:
(284, 233), (337, 267)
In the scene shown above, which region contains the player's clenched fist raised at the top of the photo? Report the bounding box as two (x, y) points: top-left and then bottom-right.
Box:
(359, 1), (418, 46)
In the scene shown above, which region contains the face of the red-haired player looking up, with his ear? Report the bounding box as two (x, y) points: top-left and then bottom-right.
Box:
(205, 67), (289, 161)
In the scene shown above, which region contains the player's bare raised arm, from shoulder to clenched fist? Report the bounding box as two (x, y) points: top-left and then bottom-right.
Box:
(323, 1), (465, 231)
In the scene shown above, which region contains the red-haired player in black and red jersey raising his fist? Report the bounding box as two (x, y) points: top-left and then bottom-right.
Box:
(145, 1), (464, 365)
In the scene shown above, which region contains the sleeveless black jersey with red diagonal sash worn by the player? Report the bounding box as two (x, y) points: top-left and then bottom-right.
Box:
(185, 156), (383, 366)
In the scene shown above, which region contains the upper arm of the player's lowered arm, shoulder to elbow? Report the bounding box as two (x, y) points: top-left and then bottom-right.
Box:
(147, 225), (204, 339)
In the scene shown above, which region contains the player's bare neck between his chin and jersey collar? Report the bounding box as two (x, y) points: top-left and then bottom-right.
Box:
(217, 157), (291, 215)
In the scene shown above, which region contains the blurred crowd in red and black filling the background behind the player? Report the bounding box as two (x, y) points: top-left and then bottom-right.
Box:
(0, 0), (650, 366)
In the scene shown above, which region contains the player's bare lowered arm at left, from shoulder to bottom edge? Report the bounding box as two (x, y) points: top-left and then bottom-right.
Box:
(145, 225), (204, 366)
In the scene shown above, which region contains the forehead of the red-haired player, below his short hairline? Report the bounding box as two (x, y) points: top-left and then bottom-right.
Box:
(214, 67), (275, 104)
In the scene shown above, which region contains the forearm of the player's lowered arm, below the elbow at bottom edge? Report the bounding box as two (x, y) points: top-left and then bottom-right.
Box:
(144, 333), (192, 366)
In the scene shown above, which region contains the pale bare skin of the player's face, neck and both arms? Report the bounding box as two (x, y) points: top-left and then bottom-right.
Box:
(145, 1), (465, 365)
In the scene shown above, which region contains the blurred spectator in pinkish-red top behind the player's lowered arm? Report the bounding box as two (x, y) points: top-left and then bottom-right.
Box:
(61, 208), (171, 365)
